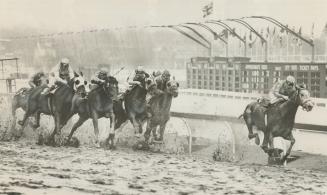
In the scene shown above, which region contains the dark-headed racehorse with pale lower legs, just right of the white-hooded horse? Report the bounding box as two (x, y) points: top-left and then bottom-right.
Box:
(67, 76), (118, 148)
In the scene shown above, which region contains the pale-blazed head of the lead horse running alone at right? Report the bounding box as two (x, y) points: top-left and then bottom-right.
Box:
(293, 85), (314, 112)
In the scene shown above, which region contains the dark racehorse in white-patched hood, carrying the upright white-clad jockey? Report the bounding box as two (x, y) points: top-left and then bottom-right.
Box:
(18, 72), (87, 144)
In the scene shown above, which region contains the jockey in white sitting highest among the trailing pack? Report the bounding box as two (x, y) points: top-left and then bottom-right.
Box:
(42, 58), (74, 95)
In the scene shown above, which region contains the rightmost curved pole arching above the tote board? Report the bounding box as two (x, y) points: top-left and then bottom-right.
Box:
(246, 16), (315, 62)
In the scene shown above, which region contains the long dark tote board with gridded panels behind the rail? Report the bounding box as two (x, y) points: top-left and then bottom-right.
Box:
(186, 57), (327, 98)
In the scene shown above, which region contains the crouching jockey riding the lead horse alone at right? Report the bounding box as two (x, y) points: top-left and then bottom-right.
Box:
(269, 75), (295, 105)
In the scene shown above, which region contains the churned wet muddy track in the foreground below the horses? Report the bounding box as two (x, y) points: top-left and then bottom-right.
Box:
(0, 141), (327, 194)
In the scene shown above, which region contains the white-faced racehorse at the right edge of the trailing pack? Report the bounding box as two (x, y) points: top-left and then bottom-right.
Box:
(144, 80), (179, 143)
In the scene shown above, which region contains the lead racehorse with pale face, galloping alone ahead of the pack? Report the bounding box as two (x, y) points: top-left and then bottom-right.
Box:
(240, 86), (314, 162)
